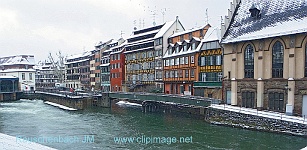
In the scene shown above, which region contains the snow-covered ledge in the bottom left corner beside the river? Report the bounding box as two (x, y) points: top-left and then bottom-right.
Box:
(0, 133), (55, 150)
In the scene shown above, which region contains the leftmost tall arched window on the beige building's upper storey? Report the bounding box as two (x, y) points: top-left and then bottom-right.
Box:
(244, 44), (254, 78)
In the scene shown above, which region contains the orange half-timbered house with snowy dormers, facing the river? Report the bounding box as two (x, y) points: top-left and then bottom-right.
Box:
(163, 25), (210, 95)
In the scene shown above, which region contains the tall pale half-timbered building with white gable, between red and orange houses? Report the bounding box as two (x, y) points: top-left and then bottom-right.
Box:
(125, 17), (184, 92)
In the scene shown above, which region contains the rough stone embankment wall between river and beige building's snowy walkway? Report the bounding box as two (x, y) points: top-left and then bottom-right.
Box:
(206, 108), (307, 137)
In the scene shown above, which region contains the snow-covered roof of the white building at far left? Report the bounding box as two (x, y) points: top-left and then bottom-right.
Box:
(0, 55), (35, 66)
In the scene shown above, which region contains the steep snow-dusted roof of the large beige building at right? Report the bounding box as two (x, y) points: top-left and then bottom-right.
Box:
(222, 0), (307, 43)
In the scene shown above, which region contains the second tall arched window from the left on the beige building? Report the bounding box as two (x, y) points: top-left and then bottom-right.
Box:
(272, 41), (284, 78)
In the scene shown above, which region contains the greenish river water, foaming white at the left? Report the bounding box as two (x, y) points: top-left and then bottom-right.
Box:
(0, 100), (307, 150)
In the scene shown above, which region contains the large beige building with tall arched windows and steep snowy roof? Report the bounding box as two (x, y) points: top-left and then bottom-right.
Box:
(221, 0), (307, 116)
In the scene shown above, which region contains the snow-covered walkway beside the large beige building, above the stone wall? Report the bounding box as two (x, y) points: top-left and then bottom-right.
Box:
(209, 104), (307, 124)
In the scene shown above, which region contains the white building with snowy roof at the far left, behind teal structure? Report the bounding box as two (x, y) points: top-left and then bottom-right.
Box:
(0, 55), (36, 91)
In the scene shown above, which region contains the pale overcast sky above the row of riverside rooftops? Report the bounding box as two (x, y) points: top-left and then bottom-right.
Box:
(0, 0), (231, 62)
